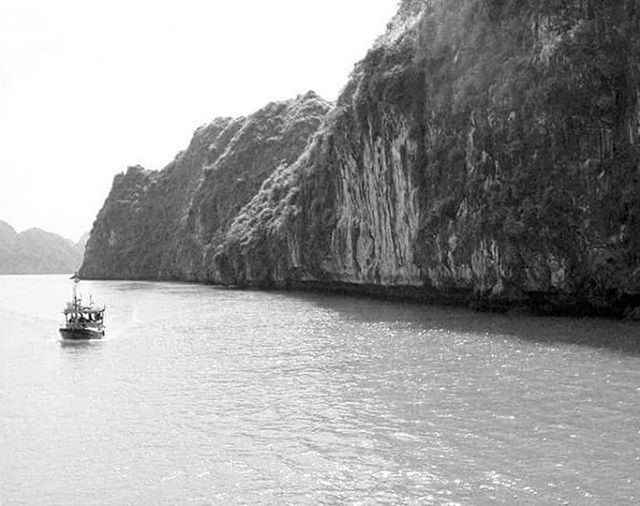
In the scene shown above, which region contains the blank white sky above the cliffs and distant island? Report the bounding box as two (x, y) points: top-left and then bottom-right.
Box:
(0, 0), (398, 240)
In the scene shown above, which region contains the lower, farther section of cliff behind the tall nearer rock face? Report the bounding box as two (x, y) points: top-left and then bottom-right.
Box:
(80, 92), (329, 280)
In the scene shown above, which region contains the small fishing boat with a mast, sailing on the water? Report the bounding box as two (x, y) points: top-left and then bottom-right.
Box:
(60, 274), (106, 341)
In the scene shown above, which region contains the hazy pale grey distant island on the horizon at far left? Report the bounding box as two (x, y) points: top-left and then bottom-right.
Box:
(0, 220), (89, 274)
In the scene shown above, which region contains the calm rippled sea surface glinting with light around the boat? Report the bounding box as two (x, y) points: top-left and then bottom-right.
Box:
(0, 276), (640, 505)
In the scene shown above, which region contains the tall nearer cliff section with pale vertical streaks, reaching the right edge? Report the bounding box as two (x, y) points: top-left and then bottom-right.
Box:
(214, 0), (640, 314)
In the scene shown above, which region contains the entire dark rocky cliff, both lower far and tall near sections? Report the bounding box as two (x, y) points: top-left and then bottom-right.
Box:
(81, 0), (640, 320)
